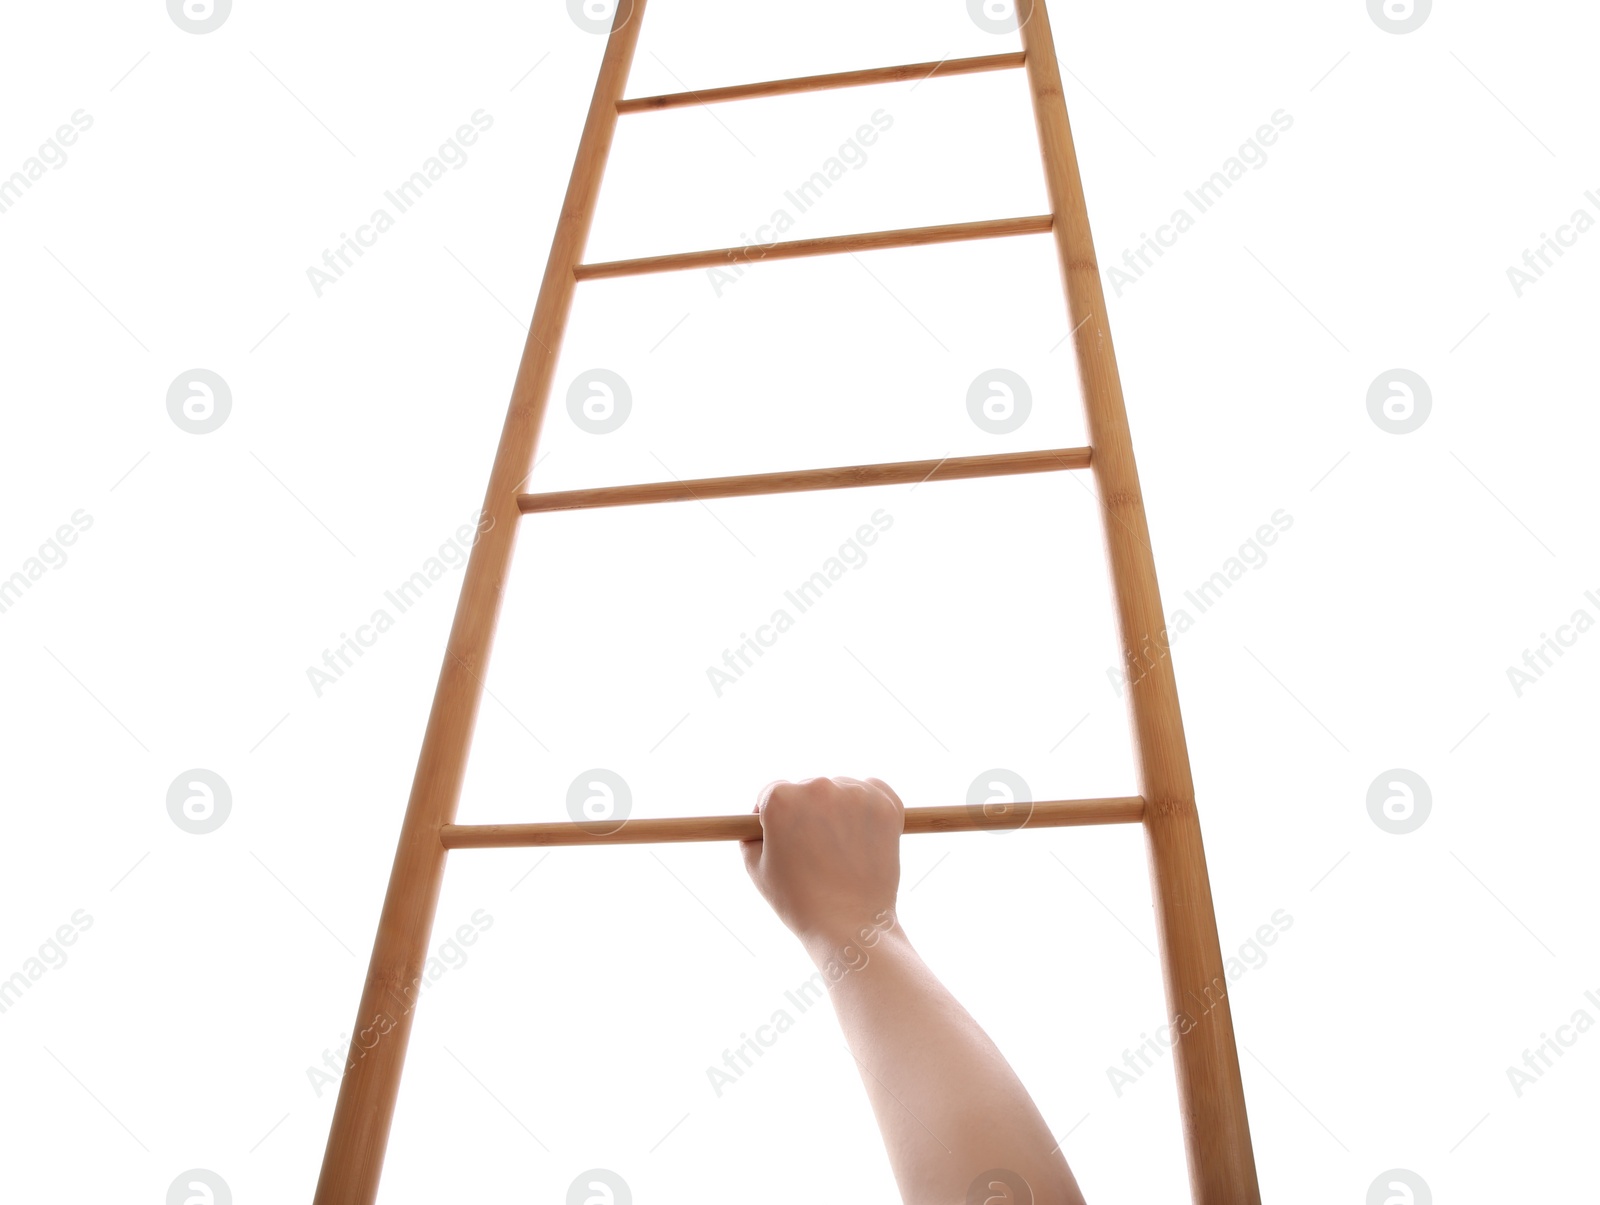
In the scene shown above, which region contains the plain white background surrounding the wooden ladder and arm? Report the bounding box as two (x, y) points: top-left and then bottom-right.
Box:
(0, 0), (1600, 1205)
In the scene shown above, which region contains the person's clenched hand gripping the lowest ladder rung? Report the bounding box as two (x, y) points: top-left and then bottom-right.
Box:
(744, 778), (906, 946)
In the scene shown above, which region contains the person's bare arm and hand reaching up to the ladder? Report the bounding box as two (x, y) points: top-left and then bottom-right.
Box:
(742, 778), (1083, 1205)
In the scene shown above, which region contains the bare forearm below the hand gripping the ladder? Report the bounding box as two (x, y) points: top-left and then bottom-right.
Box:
(805, 922), (1082, 1205)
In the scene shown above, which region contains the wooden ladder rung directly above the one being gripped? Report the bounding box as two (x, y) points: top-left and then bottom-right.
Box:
(517, 448), (1091, 515)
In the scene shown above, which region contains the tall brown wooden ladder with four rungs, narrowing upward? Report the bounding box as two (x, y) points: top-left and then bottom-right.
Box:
(315, 0), (1261, 1205)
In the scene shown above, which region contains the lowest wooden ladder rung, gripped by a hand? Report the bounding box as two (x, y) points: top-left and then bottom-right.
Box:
(438, 795), (1144, 850)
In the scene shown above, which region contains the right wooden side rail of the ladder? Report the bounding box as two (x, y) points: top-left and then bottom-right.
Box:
(1018, 0), (1261, 1205)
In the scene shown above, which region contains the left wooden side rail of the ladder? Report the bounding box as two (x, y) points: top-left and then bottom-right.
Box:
(314, 0), (645, 1205)
